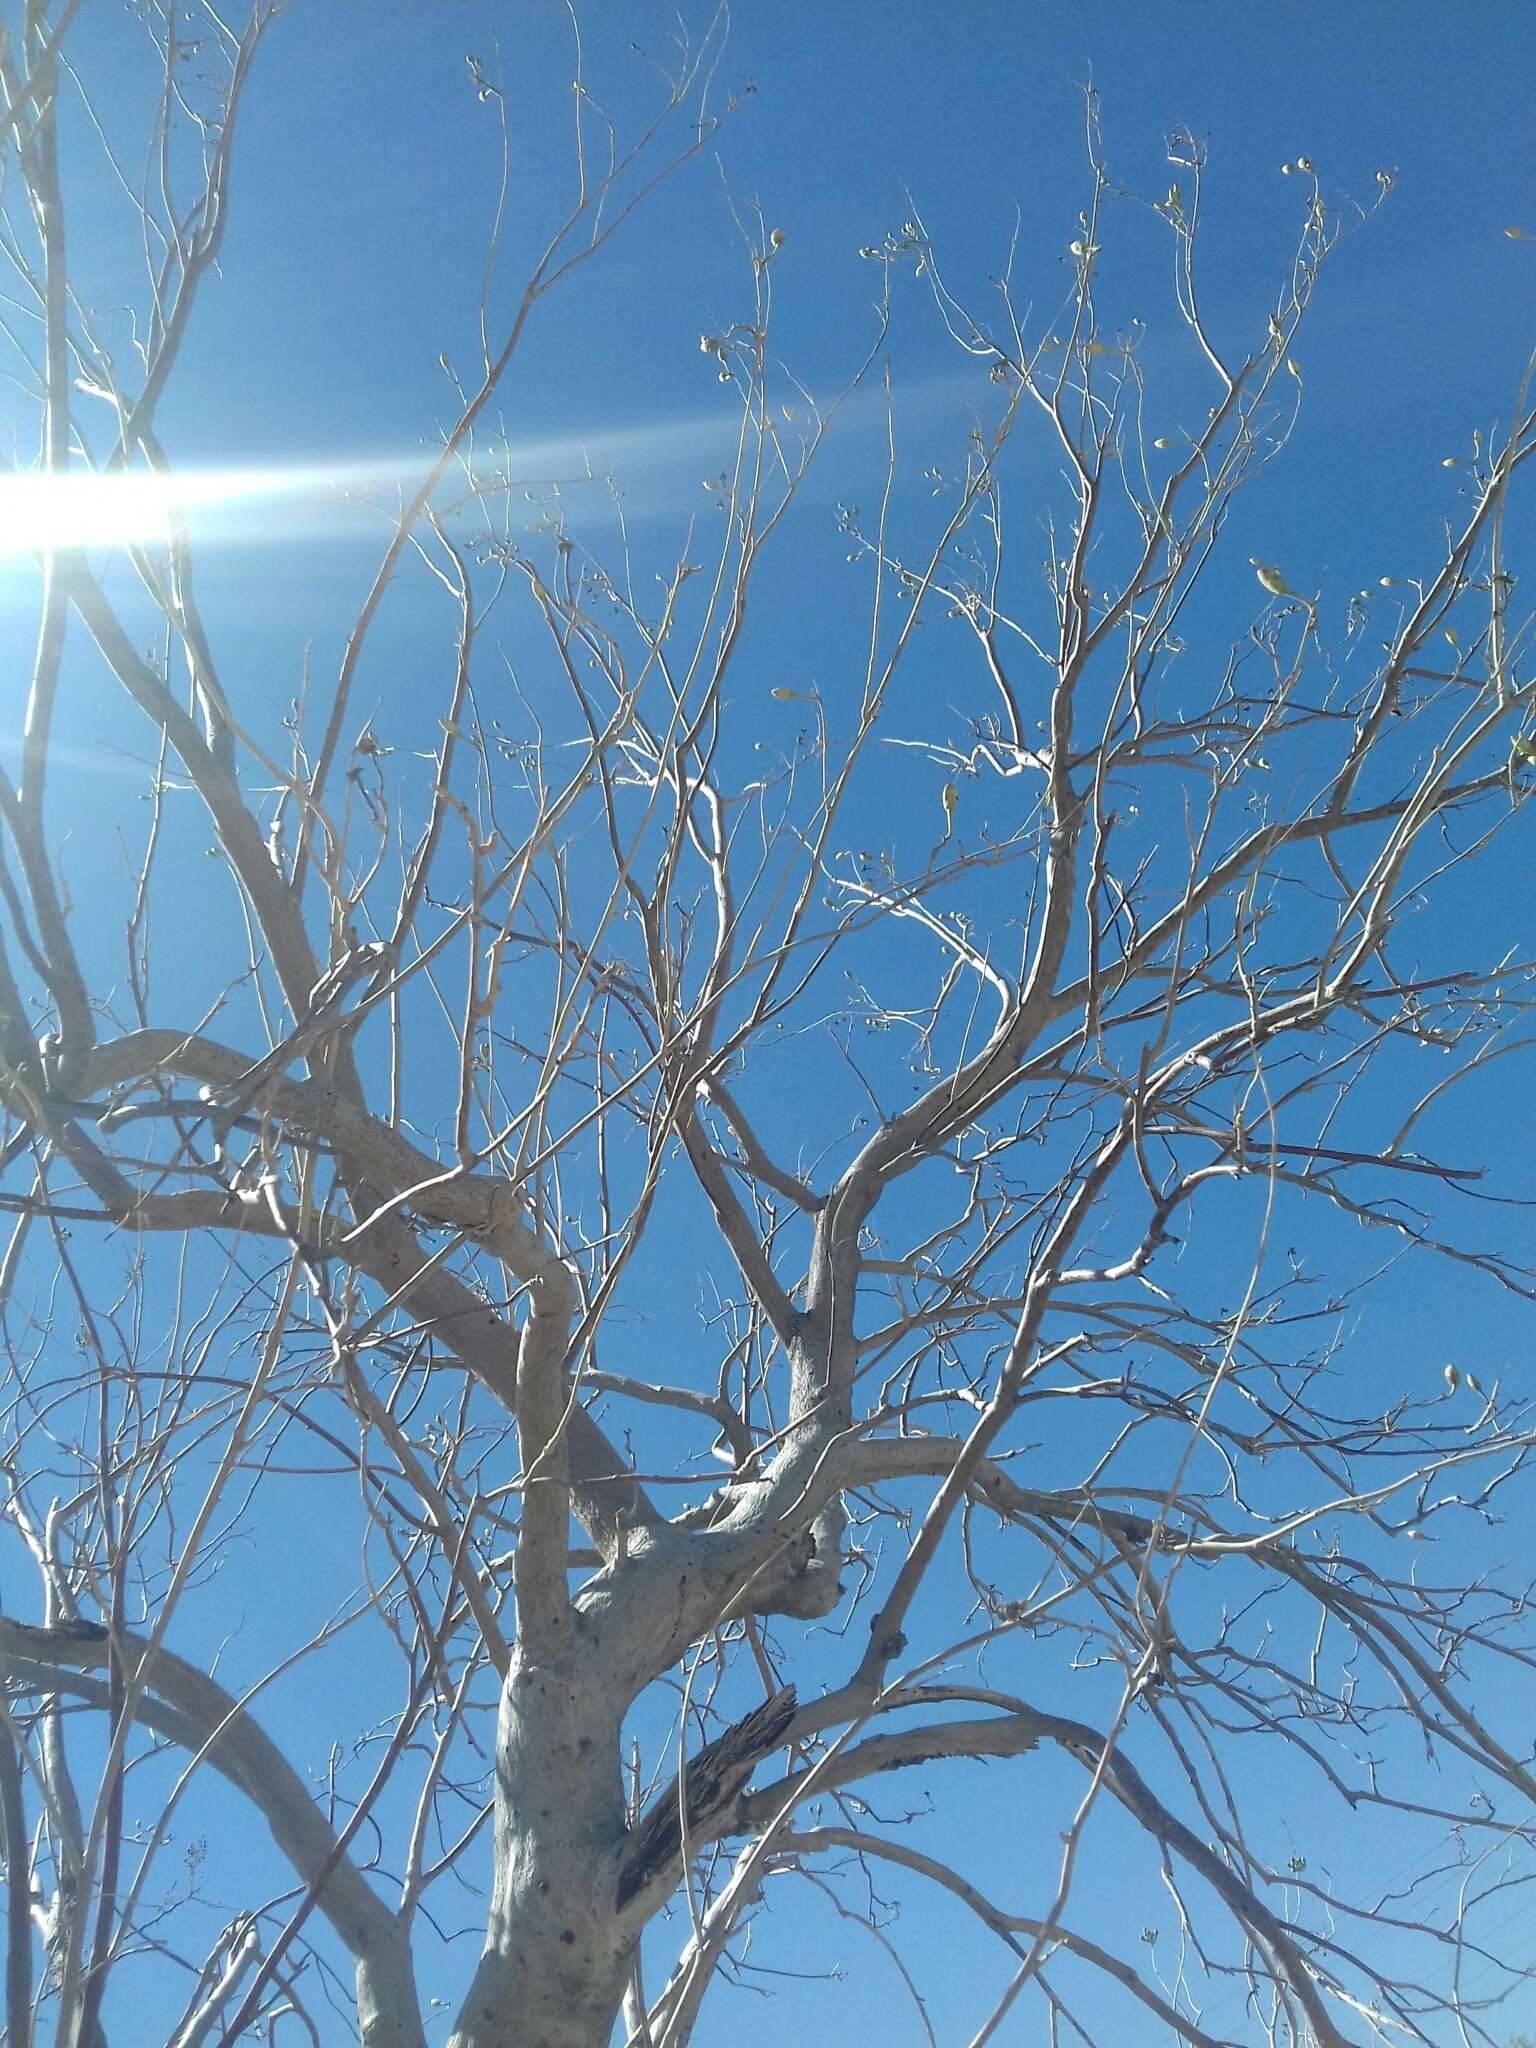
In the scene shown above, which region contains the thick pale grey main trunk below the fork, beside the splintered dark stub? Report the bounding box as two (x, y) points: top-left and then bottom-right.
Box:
(451, 1655), (635, 2048)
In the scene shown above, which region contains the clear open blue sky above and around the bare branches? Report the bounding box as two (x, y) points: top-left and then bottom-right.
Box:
(0, 0), (1536, 2048)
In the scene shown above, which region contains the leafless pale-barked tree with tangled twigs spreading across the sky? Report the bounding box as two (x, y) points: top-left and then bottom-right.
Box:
(0, 12), (1536, 2048)
